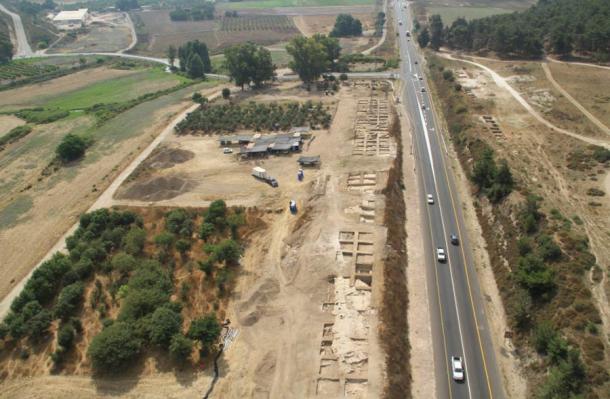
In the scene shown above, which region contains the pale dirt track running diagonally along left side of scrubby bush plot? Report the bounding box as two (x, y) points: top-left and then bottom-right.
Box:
(0, 88), (221, 319)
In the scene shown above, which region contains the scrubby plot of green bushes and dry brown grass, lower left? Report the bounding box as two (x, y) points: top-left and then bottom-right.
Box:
(0, 200), (256, 374)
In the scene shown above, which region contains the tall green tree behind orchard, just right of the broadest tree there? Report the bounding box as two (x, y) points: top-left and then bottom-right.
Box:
(286, 36), (330, 90)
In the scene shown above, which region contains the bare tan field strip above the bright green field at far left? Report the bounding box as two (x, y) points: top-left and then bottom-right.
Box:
(0, 67), (138, 110)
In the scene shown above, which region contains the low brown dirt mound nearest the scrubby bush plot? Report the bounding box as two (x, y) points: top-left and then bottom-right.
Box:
(117, 175), (195, 201)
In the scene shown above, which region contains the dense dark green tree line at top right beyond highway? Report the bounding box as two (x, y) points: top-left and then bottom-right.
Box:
(418, 0), (610, 61)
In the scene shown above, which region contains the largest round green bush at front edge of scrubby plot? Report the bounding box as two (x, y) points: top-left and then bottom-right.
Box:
(87, 322), (142, 372)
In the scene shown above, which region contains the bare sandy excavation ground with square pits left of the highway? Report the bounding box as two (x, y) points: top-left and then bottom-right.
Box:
(0, 80), (395, 398)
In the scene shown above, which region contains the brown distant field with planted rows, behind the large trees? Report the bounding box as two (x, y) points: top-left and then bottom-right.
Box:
(132, 11), (298, 56)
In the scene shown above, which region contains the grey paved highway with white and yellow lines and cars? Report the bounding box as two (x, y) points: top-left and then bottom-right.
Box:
(394, 1), (504, 399)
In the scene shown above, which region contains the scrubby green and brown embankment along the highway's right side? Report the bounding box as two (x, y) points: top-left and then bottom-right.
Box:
(428, 56), (608, 399)
